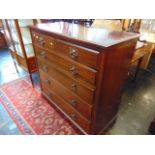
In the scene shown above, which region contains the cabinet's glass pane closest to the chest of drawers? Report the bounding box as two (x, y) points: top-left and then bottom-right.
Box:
(18, 19), (34, 57)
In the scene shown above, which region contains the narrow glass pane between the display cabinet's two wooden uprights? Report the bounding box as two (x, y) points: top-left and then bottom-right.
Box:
(8, 19), (24, 57)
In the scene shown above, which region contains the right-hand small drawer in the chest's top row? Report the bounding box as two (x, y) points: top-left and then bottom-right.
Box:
(55, 40), (99, 69)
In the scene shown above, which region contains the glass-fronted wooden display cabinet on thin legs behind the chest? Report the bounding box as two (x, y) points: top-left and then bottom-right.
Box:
(2, 19), (37, 84)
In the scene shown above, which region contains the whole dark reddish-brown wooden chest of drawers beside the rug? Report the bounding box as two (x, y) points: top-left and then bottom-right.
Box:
(30, 22), (139, 134)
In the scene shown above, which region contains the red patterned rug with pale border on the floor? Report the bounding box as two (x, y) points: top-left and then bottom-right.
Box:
(0, 78), (80, 135)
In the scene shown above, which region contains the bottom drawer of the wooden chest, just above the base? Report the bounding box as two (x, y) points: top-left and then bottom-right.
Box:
(42, 83), (90, 133)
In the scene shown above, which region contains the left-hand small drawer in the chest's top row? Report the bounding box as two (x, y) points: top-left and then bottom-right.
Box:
(32, 32), (55, 49)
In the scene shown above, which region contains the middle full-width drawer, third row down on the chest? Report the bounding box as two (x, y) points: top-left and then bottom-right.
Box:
(38, 59), (95, 104)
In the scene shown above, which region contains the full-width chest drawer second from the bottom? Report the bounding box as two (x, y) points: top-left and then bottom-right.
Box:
(40, 71), (92, 120)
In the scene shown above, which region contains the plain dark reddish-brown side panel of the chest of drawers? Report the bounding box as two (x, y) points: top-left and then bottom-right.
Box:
(94, 39), (137, 134)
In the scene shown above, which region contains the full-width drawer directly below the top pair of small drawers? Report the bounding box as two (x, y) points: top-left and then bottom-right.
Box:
(35, 44), (97, 84)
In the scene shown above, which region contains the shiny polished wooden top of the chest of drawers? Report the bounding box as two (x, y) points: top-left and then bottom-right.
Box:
(30, 22), (139, 49)
